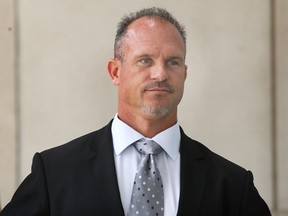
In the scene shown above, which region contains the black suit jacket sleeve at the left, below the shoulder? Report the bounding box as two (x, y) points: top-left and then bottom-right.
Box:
(0, 153), (50, 216)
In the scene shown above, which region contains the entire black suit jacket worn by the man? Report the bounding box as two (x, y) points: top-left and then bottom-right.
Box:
(0, 122), (270, 216)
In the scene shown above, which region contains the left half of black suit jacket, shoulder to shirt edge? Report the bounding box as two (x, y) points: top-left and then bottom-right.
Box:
(0, 122), (124, 216)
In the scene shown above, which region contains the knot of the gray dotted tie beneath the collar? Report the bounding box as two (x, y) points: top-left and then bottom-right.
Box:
(134, 138), (163, 155)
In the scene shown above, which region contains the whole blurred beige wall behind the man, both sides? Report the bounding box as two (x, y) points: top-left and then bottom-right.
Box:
(0, 0), (288, 216)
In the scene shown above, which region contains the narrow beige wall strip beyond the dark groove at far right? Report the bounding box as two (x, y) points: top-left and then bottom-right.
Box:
(275, 0), (288, 212)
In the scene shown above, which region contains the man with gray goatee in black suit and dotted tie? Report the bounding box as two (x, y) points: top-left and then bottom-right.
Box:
(0, 8), (271, 216)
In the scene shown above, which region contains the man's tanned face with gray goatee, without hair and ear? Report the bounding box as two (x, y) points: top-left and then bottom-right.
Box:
(110, 17), (187, 118)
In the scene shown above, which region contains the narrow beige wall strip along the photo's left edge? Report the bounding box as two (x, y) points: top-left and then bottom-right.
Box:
(0, 0), (16, 208)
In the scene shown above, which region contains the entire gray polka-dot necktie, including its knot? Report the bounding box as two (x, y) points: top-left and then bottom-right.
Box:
(129, 139), (164, 216)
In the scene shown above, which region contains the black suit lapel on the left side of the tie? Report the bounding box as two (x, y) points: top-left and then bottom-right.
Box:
(88, 122), (124, 215)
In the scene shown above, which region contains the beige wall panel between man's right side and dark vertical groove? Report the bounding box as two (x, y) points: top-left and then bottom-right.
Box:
(179, 0), (273, 206)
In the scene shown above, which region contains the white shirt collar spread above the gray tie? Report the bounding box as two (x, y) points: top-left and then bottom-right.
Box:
(111, 114), (180, 160)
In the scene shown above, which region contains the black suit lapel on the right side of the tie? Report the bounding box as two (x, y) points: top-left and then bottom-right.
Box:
(178, 129), (207, 216)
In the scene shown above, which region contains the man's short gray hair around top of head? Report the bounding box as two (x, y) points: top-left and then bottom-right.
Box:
(114, 7), (186, 61)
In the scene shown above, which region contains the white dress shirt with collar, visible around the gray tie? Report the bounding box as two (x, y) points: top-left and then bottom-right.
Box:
(111, 115), (180, 216)
